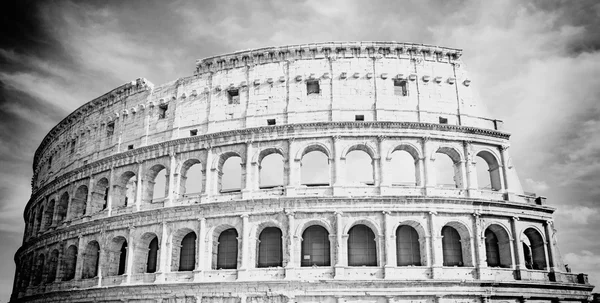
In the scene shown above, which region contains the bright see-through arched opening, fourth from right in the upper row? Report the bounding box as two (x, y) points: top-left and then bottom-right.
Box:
(344, 149), (375, 185)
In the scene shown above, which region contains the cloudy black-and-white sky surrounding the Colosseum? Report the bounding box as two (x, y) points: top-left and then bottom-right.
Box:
(0, 0), (600, 301)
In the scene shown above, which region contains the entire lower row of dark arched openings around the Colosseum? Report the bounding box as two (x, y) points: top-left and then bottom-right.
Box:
(20, 223), (547, 287)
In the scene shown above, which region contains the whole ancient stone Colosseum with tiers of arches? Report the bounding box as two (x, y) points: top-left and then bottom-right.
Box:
(11, 42), (593, 303)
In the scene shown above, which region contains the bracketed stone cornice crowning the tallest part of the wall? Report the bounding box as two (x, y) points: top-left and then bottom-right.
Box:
(195, 41), (462, 74)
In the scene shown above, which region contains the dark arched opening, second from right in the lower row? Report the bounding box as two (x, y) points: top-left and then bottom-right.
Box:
(484, 224), (512, 268)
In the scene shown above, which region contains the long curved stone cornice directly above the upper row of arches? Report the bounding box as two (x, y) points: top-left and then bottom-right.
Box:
(24, 121), (510, 214)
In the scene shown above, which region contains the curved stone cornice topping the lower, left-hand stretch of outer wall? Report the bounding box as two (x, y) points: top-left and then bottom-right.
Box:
(33, 78), (154, 171)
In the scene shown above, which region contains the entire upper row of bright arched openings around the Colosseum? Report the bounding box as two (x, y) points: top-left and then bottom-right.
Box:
(28, 144), (502, 238)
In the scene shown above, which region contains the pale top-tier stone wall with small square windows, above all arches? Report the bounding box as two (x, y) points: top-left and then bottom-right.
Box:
(32, 43), (500, 190)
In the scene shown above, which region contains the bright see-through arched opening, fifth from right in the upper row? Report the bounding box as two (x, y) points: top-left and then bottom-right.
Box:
(300, 149), (330, 187)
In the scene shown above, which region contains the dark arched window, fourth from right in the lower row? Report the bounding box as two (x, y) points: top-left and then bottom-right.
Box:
(396, 225), (421, 266)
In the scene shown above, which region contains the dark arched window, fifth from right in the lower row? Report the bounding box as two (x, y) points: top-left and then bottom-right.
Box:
(348, 224), (377, 266)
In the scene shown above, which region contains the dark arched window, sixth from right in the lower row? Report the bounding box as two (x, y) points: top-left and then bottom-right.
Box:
(300, 225), (331, 266)
